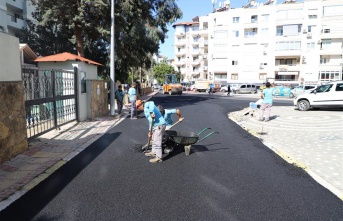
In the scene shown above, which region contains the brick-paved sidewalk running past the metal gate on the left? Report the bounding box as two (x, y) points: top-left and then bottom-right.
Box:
(0, 92), (156, 211)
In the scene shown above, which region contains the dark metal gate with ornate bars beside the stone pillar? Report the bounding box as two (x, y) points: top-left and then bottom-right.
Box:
(22, 66), (78, 139)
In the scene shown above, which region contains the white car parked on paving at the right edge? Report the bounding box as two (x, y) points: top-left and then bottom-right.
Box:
(294, 81), (343, 111)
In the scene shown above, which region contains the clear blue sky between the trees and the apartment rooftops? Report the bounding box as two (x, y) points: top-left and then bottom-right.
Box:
(160, 0), (258, 59)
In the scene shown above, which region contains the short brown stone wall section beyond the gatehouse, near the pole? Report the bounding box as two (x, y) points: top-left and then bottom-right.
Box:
(87, 80), (109, 119)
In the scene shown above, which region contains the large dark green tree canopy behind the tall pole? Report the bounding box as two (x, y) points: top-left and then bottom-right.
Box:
(19, 0), (182, 81)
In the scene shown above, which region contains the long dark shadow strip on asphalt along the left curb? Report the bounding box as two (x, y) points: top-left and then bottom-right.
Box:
(0, 132), (121, 221)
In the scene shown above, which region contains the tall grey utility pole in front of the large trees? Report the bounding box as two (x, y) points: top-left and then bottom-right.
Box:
(110, 0), (116, 116)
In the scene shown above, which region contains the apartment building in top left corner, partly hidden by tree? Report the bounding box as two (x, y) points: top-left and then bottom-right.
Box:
(0, 0), (35, 36)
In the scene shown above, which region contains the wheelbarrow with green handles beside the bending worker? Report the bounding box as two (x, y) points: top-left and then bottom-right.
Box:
(162, 127), (219, 156)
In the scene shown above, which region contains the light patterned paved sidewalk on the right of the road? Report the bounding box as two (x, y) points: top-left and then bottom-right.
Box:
(229, 106), (343, 200)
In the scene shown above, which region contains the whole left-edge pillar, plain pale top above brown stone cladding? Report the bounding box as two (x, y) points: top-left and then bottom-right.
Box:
(0, 32), (28, 163)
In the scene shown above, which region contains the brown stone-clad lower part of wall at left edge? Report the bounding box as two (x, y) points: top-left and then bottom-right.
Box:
(0, 81), (28, 163)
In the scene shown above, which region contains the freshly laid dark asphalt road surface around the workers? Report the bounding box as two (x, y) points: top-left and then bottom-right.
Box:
(0, 94), (343, 221)
